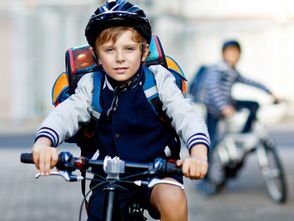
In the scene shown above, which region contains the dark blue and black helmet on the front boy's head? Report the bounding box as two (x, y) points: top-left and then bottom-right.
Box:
(85, 0), (152, 48)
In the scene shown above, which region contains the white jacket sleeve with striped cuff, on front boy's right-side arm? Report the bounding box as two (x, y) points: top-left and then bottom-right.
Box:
(150, 65), (210, 150)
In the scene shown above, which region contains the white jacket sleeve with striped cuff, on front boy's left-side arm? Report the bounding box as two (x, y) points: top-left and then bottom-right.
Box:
(35, 73), (93, 147)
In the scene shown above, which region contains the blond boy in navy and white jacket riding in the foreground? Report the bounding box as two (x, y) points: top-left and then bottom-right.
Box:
(33, 0), (209, 221)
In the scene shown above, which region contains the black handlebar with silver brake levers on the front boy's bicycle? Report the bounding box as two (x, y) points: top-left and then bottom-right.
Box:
(20, 152), (184, 220)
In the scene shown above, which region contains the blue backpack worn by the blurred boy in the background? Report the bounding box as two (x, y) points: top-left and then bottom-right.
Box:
(189, 65), (209, 103)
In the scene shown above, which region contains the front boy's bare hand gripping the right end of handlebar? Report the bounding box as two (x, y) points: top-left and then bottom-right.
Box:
(177, 144), (208, 179)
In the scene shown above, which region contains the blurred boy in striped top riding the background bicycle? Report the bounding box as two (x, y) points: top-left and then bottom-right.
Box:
(198, 40), (277, 194)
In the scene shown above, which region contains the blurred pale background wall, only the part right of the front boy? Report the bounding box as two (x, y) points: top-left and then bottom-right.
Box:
(155, 0), (294, 116)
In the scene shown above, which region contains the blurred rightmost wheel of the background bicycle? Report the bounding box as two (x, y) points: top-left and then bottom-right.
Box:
(257, 139), (287, 203)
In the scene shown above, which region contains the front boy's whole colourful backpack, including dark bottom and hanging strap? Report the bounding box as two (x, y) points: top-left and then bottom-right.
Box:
(52, 34), (186, 204)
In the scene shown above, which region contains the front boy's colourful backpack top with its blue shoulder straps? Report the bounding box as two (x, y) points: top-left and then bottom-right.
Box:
(52, 34), (186, 119)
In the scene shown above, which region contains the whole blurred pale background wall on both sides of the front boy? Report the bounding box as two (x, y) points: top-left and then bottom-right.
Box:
(0, 0), (294, 121)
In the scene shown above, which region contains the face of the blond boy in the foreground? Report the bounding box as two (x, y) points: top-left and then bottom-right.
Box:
(96, 31), (149, 82)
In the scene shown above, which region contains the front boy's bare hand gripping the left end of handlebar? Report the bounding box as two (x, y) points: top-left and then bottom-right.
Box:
(32, 137), (58, 176)
